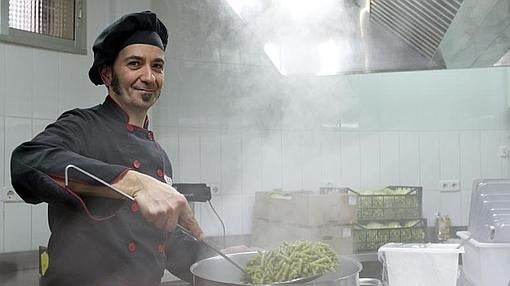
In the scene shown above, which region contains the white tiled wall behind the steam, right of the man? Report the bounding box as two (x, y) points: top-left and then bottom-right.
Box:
(152, 0), (510, 235)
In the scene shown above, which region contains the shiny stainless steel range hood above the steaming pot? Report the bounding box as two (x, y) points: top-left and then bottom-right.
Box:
(226, 0), (510, 75)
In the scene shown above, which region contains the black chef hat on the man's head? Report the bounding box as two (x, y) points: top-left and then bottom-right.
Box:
(89, 11), (168, 85)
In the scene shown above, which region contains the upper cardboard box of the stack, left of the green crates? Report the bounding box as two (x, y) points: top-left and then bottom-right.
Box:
(253, 191), (357, 226)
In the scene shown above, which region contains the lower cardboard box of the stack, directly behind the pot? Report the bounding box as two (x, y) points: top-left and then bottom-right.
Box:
(251, 219), (353, 255)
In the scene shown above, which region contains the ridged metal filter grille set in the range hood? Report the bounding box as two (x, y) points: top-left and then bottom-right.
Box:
(370, 0), (463, 59)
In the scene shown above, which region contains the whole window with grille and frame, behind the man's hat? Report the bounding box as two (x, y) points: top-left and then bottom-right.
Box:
(0, 0), (87, 54)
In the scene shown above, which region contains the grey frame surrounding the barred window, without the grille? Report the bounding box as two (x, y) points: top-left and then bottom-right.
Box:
(0, 0), (87, 55)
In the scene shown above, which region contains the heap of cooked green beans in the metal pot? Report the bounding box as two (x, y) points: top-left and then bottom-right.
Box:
(244, 241), (337, 284)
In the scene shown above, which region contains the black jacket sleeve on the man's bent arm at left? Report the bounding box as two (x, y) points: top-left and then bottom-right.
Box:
(11, 109), (128, 210)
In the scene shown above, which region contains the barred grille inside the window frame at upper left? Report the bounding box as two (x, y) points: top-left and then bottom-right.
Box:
(9, 0), (75, 40)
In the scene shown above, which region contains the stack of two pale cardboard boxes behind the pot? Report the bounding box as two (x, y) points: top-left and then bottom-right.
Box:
(252, 191), (357, 254)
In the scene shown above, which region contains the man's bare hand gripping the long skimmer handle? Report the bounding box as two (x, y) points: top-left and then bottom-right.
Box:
(113, 170), (204, 239)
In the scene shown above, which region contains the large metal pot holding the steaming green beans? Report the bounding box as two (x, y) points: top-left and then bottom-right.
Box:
(190, 252), (377, 286)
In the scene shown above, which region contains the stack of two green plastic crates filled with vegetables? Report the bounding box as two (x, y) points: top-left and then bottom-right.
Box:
(350, 186), (427, 252)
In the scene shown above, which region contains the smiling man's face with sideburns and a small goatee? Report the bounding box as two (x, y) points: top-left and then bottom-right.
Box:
(106, 44), (165, 111)
